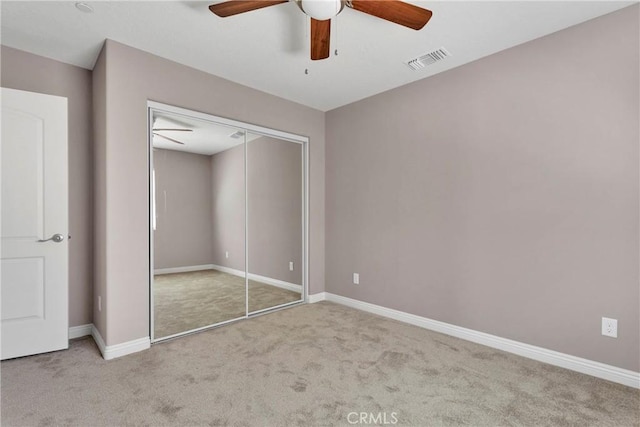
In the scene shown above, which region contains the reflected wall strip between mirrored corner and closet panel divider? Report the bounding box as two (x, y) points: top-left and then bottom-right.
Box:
(211, 144), (245, 271)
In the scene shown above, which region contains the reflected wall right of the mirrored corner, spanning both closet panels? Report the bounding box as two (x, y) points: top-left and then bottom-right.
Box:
(211, 137), (302, 285)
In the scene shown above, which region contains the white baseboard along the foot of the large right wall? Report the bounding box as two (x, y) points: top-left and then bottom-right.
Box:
(316, 292), (640, 388)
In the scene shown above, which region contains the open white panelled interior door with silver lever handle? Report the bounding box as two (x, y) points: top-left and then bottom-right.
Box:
(0, 88), (69, 359)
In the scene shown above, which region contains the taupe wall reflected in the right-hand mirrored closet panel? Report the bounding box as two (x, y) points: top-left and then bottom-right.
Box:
(247, 137), (302, 285)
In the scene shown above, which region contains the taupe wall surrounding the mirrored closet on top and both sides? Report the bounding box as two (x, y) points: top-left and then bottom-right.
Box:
(96, 41), (325, 345)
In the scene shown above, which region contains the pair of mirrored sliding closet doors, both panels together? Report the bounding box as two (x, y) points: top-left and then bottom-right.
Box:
(149, 102), (306, 342)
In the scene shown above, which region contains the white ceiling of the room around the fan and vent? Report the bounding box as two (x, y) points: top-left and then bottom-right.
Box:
(0, 0), (637, 111)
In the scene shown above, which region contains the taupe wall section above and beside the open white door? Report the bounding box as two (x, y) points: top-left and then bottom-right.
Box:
(0, 46), (93, 326)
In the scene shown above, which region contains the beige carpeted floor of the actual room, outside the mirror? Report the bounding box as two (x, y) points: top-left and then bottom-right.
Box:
(1, 302), (640, 427)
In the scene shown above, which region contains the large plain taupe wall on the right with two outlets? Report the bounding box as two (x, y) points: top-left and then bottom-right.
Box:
(326, 6), (640, 371)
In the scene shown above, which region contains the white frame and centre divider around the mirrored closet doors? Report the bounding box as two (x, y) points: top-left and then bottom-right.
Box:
(147, 100), (309, 344)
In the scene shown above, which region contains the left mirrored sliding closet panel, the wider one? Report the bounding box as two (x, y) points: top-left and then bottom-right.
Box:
(152, 112), (246, 338)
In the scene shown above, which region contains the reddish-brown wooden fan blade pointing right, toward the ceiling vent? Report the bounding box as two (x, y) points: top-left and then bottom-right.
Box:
(346, 0), (433, 30)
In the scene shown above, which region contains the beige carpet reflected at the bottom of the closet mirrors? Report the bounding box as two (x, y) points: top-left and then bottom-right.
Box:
(153, 270), (301, 338)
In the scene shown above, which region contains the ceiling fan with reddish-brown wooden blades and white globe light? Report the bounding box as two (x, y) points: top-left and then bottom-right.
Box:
(209, 0), (432, 60)
